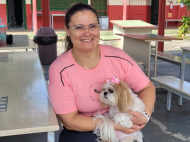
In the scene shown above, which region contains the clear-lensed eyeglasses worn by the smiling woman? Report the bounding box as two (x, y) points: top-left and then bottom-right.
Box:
(69, 23), (101, 35)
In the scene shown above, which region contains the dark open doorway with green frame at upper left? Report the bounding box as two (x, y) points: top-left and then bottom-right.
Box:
(7, 0), (26, 30)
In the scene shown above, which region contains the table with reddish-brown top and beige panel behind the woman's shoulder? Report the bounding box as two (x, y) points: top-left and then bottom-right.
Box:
(116, 34), (182, 77)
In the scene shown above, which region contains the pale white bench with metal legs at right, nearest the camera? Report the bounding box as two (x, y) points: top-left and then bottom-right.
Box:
(151, 76), (190, 110)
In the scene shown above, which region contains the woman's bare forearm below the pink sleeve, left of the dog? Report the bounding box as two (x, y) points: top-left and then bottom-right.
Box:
(57, 111), (100, 131)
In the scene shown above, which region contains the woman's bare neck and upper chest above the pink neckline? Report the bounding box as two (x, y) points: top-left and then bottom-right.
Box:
(71, 47), (101, 69)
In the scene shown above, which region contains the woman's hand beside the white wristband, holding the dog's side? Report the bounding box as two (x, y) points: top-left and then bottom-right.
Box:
(128, 110), (147, 125)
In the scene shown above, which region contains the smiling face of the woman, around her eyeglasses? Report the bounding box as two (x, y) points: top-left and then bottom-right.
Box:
(65, 10), (100, 52)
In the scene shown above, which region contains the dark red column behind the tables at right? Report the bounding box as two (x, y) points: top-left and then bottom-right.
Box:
(158, 0), (166, 52)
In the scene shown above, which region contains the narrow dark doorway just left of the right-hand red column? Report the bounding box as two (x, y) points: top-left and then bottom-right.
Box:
(151, 0), (159, 25)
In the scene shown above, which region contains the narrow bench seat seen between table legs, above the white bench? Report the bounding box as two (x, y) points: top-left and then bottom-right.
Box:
(151, 50), (190, 66)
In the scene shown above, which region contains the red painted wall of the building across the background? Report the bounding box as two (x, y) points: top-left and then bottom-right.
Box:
(0, 4), (187, 29)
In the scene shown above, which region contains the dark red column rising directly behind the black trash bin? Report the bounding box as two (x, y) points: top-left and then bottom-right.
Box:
(41, 0), (50, 27)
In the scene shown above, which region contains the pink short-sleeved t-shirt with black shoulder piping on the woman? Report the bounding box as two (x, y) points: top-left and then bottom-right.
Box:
(49, 45), (149, 116)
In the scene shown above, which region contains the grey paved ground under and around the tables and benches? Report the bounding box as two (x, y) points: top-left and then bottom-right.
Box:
(0, 28), (190, 142)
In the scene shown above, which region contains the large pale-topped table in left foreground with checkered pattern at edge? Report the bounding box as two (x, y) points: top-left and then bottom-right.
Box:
(0, 51), (59, 142)
